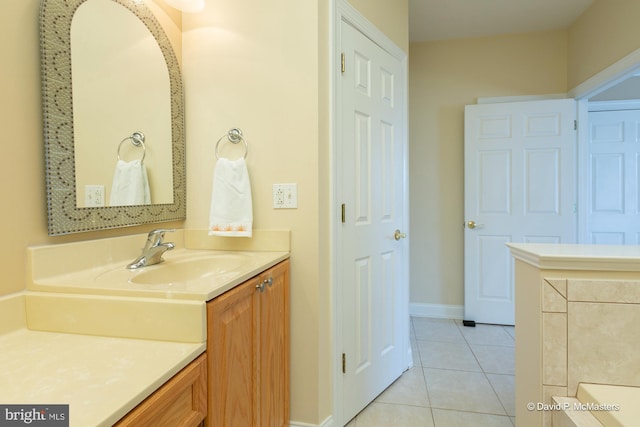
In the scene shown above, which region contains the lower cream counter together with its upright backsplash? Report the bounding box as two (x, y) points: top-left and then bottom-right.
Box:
(0, 292), (206, 427)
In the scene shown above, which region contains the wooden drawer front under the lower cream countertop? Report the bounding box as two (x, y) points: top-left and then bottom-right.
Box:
(115, 354), (207, 427)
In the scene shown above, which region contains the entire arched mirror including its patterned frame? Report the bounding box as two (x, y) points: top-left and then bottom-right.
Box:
(40, 0), (186, 235)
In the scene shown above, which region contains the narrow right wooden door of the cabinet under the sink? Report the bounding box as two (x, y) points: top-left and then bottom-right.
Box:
(259, 260), (289, 427)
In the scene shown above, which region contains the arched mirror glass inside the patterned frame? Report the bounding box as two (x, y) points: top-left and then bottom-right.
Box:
(71, 0), (173, 207)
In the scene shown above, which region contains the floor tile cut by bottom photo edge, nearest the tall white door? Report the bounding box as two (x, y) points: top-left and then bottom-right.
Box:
(349, 402), (433, 427)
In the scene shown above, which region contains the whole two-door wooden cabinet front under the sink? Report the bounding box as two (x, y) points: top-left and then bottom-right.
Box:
(205, 260), (289, 427)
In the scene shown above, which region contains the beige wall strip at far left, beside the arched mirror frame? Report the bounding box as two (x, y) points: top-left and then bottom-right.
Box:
(0, 0), (42, 294)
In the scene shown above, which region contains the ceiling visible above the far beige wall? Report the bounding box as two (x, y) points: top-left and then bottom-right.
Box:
(409, 0), (594, 42)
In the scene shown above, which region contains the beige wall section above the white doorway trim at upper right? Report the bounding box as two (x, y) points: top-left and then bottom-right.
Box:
(567, 0), (640, 89)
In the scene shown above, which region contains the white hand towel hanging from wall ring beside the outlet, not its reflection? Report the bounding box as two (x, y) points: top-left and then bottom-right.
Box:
(209, 158), (253, 237)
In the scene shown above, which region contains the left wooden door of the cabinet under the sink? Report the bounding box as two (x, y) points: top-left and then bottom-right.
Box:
(206, 280), (259, 427)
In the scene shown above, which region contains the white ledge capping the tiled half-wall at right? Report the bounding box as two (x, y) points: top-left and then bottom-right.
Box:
(507, 243), (640, 272)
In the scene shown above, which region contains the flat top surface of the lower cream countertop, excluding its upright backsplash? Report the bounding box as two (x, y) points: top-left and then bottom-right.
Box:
(0, 328), (205, 427)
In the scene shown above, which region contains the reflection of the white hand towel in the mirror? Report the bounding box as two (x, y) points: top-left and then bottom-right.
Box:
(109, 160), (151, 206)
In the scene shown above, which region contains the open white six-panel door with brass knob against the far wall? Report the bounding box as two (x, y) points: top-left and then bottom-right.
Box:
(464, 99), (576, 324)
